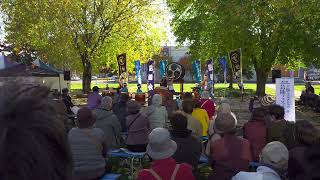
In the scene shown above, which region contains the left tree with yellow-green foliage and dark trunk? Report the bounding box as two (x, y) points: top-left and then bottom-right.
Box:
(1, 0), (165, 92)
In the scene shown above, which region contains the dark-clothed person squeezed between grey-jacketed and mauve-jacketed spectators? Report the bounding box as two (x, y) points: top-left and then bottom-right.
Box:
(113, 94), (129, 132)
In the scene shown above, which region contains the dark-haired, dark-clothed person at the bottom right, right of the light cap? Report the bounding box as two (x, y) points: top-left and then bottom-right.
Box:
(288, 120), (320, 180)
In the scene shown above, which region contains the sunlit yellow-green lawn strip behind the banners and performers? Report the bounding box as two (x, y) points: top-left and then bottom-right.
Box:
(71, 82), (275, 96)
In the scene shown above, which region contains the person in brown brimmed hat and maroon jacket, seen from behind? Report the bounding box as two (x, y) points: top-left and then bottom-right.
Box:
(209, 113), (252, 180)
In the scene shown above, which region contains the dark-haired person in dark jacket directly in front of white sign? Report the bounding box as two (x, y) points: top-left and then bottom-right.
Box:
(267, 104), (294, 150)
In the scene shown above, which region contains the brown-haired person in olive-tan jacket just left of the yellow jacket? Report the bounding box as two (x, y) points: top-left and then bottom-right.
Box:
(182, 100), (203, 137)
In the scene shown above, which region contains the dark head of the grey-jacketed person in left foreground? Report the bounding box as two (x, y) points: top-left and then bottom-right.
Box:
(76, 107), (96, 129)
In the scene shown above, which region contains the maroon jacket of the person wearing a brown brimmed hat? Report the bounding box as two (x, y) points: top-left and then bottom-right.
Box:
(209, 134), (252, 180)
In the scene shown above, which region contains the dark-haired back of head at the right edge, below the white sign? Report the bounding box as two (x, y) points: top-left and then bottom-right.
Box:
(295, 120), (320, 146)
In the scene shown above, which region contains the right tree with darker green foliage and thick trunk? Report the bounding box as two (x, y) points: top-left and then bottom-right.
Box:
(167, 0), (320, 96)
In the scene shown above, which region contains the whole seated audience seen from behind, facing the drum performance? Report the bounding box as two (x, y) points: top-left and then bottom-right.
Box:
(0, 85), (320, 180)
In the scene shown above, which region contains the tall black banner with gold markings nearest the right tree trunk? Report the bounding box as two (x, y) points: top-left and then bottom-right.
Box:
(230, 48), (243, 89)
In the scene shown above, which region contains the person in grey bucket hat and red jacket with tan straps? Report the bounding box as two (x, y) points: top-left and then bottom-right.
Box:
(138, 128), (195, 180)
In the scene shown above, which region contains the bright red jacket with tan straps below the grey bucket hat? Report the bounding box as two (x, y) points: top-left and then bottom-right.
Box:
(138, 158), (195, 180)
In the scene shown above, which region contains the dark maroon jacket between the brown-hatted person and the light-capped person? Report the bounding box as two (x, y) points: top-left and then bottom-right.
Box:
(243, 121), (267, 161)
